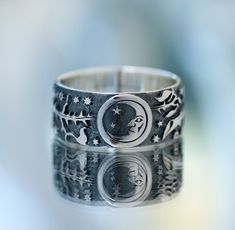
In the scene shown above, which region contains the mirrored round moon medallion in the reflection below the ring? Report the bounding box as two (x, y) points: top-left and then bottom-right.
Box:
(97, 155), (152, 207)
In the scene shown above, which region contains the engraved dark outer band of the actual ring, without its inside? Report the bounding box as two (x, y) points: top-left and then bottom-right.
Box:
(53, 65), (184, 147)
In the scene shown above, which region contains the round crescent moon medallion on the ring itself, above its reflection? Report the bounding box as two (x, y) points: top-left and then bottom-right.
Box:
(97, 94), (152, 147)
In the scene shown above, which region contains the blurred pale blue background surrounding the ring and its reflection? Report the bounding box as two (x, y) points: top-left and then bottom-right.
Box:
(0, 0), (235, 230)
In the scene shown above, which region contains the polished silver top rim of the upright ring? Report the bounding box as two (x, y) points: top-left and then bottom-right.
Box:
(55, 65), (181, 95)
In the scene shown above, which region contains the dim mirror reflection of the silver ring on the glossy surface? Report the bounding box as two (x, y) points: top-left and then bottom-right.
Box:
(53, 139), (183, 207)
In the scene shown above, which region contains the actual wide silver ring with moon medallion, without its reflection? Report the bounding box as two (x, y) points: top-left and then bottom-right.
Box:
(53, 66), (184, 147)
